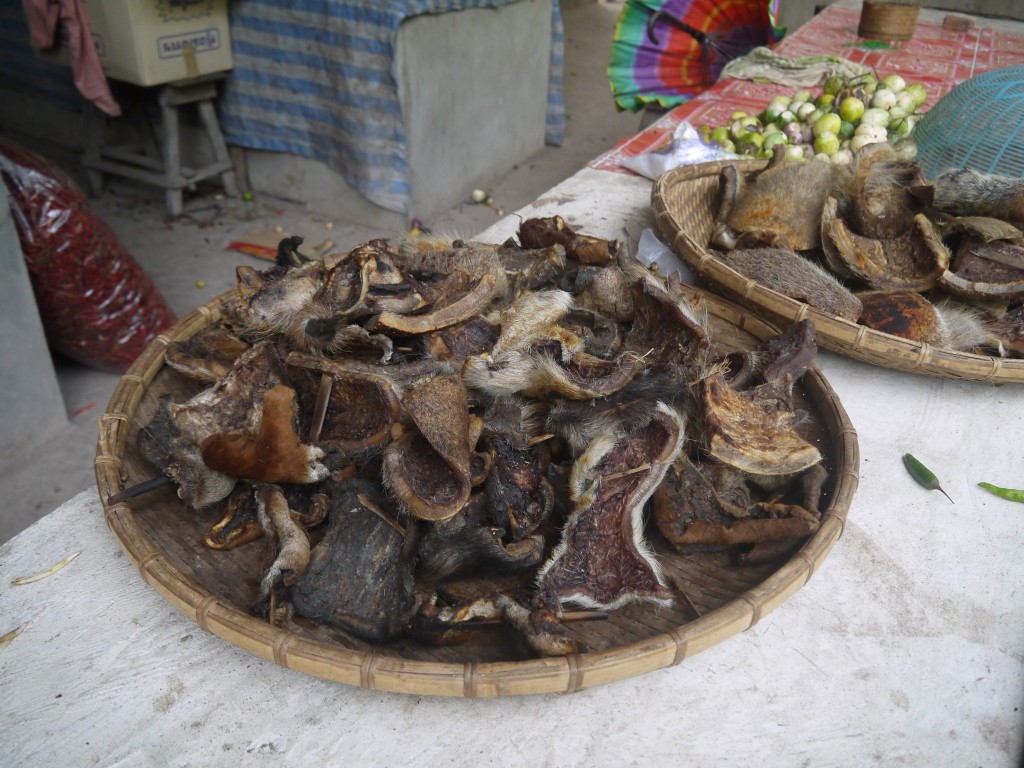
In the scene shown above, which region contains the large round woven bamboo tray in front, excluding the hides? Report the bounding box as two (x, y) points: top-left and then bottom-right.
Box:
(95, 282), (859, 696)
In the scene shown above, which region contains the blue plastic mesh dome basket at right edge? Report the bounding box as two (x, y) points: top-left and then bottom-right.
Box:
(913, 66), (1024, 178)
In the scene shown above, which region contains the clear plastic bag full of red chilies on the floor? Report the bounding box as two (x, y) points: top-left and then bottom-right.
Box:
(0, 141), (175, 373)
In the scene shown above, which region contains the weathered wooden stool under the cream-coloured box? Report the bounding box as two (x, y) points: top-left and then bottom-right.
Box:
(82, 73), (239, 217)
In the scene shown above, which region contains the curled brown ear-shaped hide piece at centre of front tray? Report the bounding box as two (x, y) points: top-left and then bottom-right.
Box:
(384, 374), (472, 521)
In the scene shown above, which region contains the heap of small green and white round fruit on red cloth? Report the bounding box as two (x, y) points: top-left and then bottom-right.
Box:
(701, 73), (928, 165)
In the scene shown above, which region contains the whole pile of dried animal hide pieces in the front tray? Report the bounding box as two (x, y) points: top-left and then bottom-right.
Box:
(138, 222), (827, 654)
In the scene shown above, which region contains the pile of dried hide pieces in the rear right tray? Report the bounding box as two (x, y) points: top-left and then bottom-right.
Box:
(712, 141), (1024, 356)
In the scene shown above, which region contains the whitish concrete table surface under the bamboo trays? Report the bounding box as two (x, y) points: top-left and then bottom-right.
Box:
(0, 169), (1024, 768)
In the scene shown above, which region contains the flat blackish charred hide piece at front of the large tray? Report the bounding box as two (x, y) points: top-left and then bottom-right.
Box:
(291, 479), (416, 642)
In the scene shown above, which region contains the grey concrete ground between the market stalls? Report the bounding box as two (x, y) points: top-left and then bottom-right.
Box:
(0, 0), (640, 543)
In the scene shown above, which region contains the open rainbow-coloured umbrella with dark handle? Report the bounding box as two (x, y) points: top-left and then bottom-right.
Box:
(608, 0), (785, 112)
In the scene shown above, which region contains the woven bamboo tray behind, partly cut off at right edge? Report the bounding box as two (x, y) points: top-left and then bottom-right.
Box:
(651, 160), (1024, 383)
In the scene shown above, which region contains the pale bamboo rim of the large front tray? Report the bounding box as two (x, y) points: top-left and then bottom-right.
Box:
(94, 287), (860, 697)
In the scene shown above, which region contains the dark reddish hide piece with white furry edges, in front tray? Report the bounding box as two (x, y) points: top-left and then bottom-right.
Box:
(538, 403), (684, 610)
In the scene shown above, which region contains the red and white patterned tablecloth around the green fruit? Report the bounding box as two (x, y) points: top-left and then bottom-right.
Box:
(588, 6), (1024, 173)
